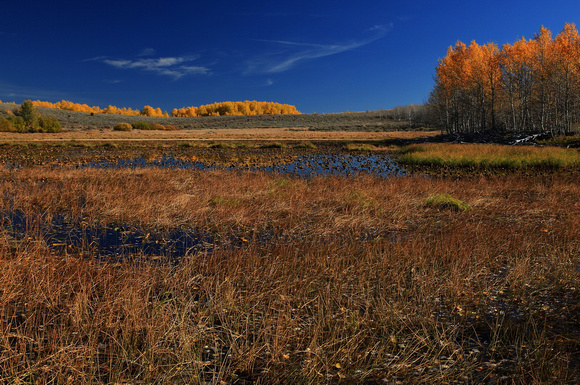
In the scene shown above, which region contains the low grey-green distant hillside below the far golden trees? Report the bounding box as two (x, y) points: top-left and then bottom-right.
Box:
(0, 103), (424, 131)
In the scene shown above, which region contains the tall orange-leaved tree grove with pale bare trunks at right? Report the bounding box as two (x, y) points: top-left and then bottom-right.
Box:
(429, 24), (580, 134)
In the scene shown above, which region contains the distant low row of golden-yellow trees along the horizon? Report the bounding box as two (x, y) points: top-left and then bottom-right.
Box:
(32, 100), (300, 118)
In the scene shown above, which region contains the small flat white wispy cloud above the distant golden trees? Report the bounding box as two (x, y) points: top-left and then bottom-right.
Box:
(96, 54), (211, 80)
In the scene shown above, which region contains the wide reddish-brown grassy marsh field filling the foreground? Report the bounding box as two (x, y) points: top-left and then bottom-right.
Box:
(0, 106), (580, 384)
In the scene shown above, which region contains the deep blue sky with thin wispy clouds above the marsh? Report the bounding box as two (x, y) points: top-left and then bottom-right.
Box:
(0, 0), (580, 113)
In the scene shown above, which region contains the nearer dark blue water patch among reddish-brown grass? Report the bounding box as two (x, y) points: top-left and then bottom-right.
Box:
(0, 210), (406, 263)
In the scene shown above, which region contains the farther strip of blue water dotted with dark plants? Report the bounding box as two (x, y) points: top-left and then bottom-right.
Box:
(83, 154), (406, 178)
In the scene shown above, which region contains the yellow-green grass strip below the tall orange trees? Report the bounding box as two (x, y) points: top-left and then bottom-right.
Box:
(399, 143), (580, 169)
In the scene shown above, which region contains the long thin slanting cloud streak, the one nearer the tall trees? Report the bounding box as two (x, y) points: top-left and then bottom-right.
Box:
(245, 24), (393, 74)
